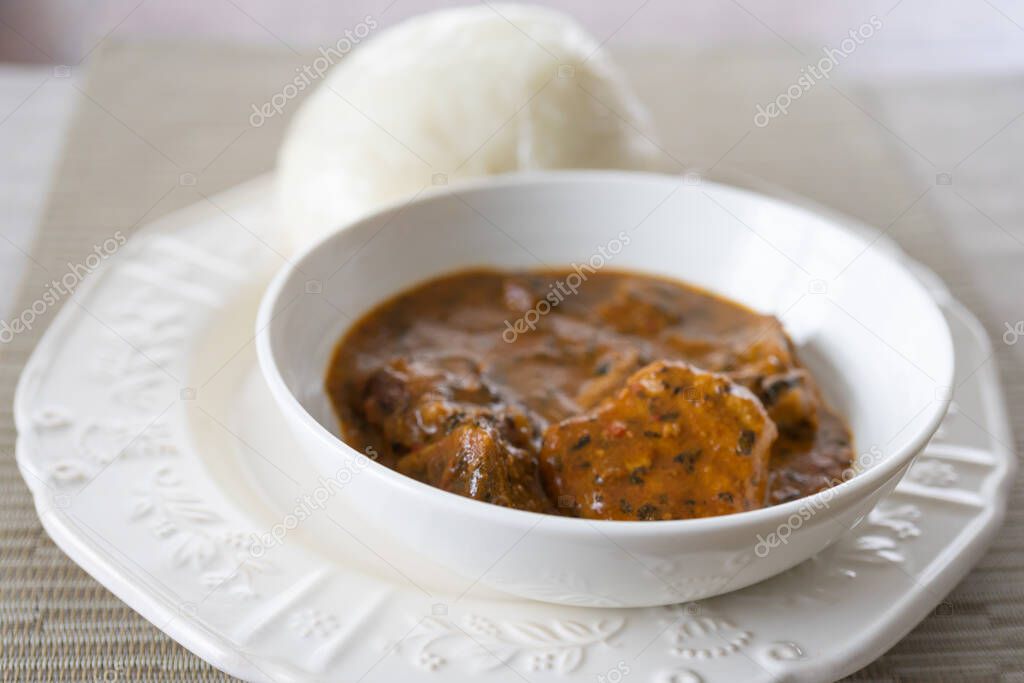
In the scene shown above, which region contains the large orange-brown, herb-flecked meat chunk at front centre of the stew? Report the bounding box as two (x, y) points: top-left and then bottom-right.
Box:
(541, 361), (776, 519)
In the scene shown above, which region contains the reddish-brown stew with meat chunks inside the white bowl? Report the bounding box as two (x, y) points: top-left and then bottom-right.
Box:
(326, 269), (853, 520)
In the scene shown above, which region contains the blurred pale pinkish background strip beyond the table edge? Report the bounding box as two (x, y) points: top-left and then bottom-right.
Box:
(0, 0), (1024, 75)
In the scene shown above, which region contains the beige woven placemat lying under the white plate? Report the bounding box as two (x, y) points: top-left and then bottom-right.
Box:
(0, 43), (1024, 681)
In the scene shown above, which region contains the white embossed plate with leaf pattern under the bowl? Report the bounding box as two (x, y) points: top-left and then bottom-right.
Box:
(15, 179), (1014, 682)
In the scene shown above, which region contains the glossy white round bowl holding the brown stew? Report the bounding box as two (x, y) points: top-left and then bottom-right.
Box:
(257, 172), (953, 606)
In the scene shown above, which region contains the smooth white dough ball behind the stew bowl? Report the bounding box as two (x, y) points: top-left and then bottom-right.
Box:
(276, 4), (658, 248)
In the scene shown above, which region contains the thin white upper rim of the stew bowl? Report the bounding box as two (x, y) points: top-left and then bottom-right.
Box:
(255, 169), (955, 538)
